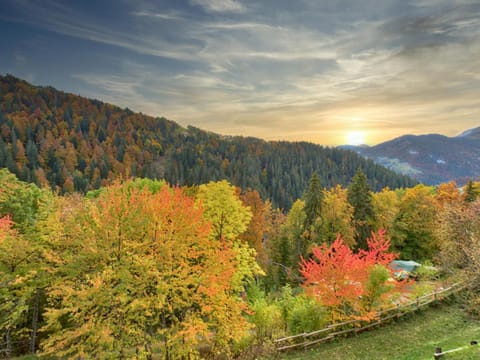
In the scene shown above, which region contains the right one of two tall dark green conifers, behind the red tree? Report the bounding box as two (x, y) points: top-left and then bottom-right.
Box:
(347, 168), (375, 249)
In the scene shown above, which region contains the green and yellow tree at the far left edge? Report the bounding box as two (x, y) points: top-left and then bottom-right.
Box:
(0, 169), (52, 353)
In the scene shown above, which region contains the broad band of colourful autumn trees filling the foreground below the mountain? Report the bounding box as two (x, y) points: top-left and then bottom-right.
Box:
(0, 169), (472, 359)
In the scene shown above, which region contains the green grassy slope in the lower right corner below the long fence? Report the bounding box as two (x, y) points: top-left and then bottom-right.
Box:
(280, 305), (480, 360)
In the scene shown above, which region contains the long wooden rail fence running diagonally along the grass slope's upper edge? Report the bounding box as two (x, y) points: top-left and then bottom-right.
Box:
(274, 283), (465, 351)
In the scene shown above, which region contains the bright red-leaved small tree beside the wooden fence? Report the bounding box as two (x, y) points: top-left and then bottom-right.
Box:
(300, 230), (396, 320)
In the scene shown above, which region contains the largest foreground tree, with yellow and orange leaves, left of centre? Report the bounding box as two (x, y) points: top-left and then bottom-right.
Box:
(42, 182), (248, 359)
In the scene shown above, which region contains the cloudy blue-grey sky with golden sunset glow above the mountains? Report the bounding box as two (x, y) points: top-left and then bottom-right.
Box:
(0, 0), (480, 146)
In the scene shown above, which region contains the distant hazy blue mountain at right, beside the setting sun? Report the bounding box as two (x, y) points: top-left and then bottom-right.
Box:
(352, 127), (480, 185)
